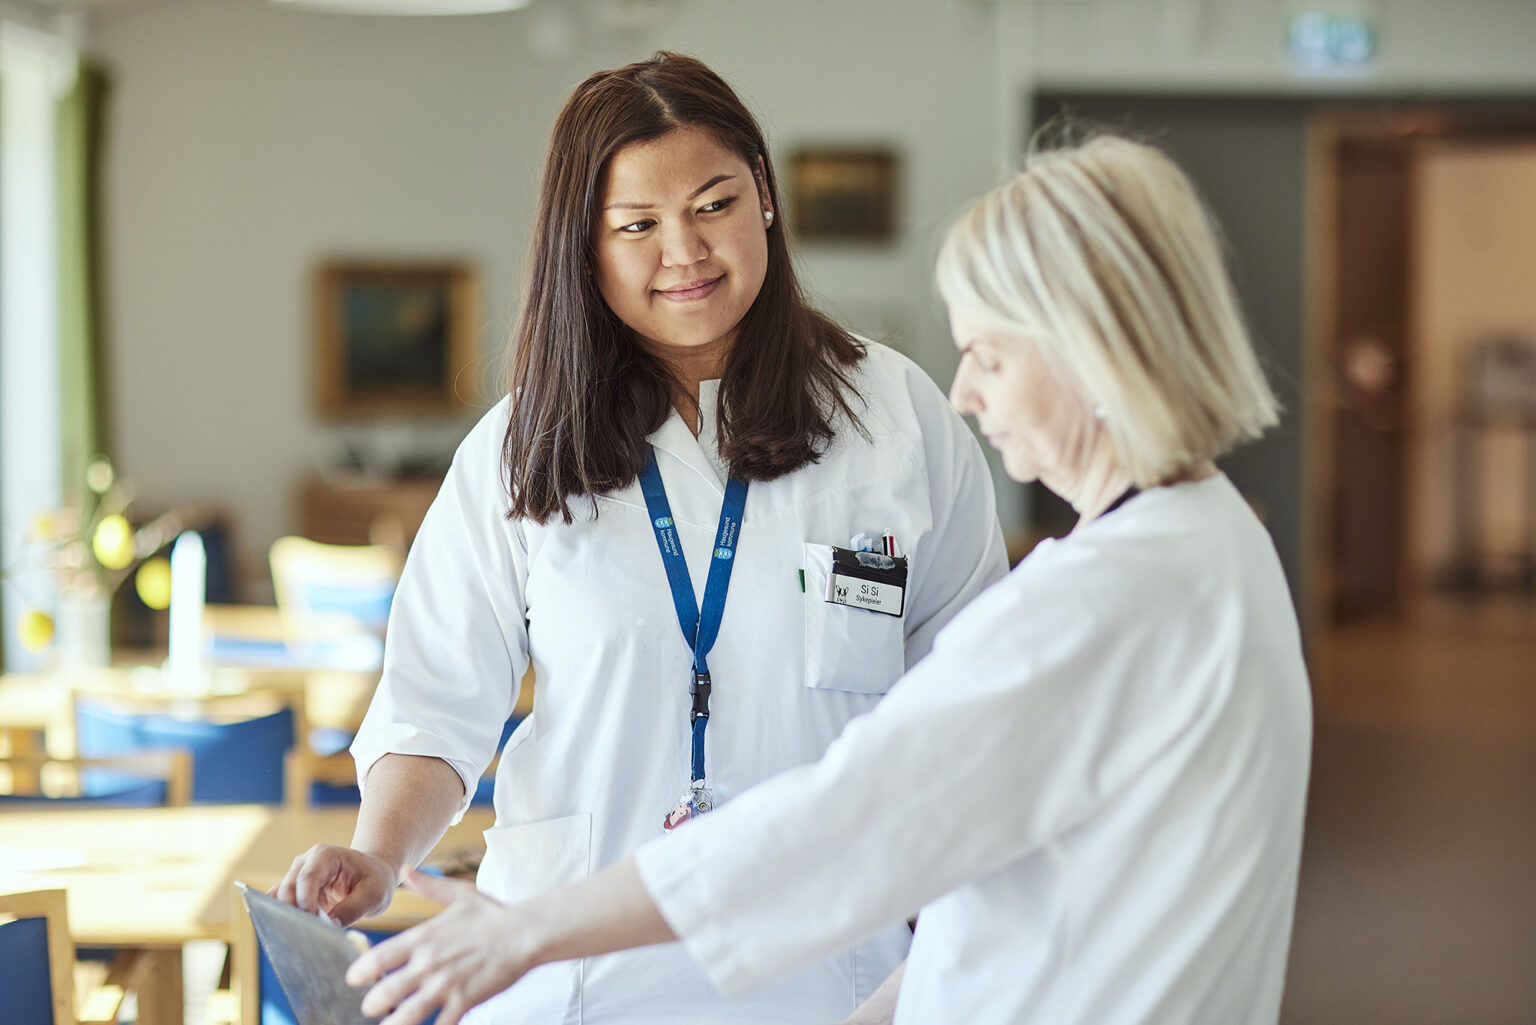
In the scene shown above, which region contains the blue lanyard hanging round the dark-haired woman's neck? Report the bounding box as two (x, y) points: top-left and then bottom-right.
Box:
(641, 447), (746, 784)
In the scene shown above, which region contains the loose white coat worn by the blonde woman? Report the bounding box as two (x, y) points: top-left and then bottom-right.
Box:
(637, 476), (1312, 1025)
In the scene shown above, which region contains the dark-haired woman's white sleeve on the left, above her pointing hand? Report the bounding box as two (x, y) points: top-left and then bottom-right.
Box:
(352, 403), (528, 821)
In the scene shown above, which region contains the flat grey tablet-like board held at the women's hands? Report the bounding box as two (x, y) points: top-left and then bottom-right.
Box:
(235, 882), (379, 1025)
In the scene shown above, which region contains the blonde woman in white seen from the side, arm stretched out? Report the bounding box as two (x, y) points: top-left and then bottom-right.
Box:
(349, 137), (1310, 1025)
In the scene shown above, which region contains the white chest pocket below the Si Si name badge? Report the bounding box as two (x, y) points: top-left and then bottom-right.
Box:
(802, 544), (906, 695)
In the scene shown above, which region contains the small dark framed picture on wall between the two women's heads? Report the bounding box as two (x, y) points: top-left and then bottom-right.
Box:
(790, 149), (895, 243)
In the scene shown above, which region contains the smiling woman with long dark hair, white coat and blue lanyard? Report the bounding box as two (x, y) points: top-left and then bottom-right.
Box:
(278, 54), (1006, 1025)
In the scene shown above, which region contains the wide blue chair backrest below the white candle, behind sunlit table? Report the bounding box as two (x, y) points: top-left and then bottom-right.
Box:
(75, 692), (303, 804)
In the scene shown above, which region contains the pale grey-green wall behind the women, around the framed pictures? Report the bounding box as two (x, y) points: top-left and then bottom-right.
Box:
(88, 0), (1536, 580)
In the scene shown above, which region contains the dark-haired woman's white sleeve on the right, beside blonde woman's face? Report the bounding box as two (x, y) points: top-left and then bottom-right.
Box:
(897, 363), (1008, 668)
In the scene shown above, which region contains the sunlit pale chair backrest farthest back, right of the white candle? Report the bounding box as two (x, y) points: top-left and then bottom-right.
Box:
(269, 536), (401, 641)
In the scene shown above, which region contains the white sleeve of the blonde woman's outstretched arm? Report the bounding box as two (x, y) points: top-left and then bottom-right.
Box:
(636, 556), (1203, 996)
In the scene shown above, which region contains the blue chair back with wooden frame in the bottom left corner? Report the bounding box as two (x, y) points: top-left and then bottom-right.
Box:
(0, 890), (75, 1025)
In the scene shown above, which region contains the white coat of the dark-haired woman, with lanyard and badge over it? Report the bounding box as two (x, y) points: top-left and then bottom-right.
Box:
(353, 344), (1008, 1025)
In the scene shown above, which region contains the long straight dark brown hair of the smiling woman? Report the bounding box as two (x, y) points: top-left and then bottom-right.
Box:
(502, 52), (863, 522)
